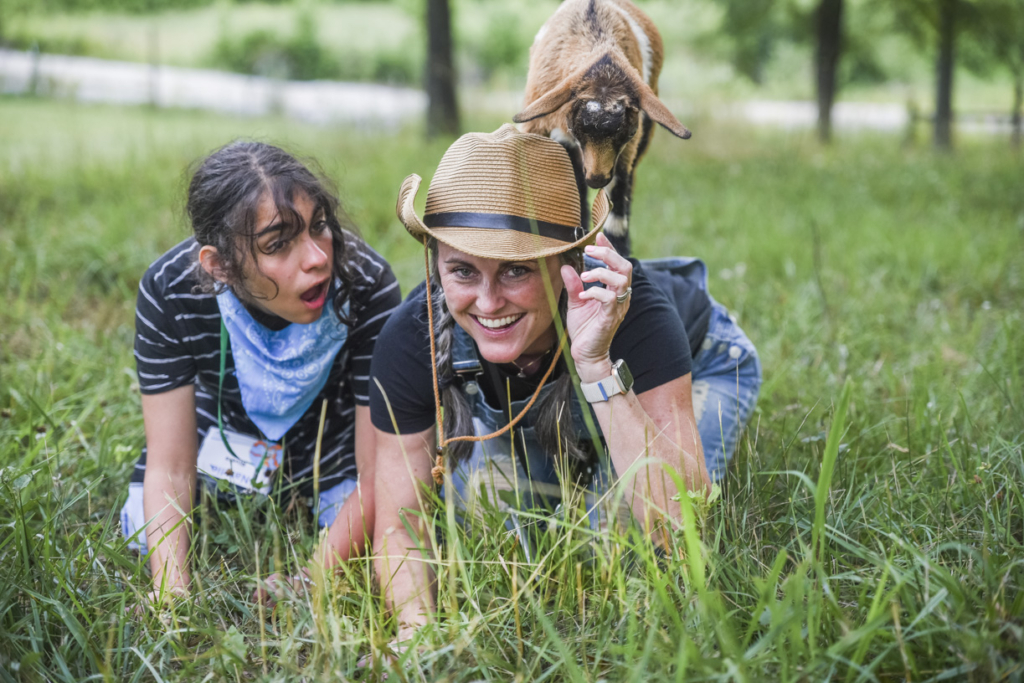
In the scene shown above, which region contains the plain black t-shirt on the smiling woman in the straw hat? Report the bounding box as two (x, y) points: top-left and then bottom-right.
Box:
(370, 259), (710, 434)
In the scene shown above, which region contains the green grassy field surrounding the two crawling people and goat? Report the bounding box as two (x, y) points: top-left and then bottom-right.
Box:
(0, 99), (1024, 682)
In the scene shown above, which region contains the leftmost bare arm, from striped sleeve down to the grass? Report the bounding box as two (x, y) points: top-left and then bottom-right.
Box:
(142, 384), (199, 592)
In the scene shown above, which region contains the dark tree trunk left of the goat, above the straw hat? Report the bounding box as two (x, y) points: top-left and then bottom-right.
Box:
(425, 0), (459, 137)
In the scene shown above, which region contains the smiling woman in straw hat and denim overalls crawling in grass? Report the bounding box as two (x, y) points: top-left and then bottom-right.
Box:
(370, 126), (761, 641)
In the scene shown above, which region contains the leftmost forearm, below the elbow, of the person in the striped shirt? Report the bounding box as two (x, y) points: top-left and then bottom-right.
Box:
(142, 468), (196, 590)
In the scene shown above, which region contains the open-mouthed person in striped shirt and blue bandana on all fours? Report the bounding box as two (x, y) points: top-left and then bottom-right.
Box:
(121, 141), (400, 597)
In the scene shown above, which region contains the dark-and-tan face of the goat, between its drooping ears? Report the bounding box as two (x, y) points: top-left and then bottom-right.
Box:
(568, 95), (640, 189)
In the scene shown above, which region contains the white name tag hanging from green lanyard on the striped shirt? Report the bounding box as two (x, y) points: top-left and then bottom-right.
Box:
(196, 428), (283, 495)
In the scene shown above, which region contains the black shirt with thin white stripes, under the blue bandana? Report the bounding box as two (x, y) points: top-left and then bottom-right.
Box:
(132, 233), (401, 496)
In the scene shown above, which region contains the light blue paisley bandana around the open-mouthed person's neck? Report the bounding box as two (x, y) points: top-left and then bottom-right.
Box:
(217, 288), (348, 441)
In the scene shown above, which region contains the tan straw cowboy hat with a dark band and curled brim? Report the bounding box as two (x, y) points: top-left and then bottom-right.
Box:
(396, 124), (610, 260)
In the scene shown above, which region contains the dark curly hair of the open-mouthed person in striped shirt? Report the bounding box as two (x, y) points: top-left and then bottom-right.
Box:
(185, 140), (358, 324)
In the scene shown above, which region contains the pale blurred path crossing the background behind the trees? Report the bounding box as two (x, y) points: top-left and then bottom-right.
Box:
(0, 49), (1010, 134)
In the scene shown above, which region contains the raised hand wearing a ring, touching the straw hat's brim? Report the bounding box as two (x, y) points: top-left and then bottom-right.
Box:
(561, 233), (633, 382)
